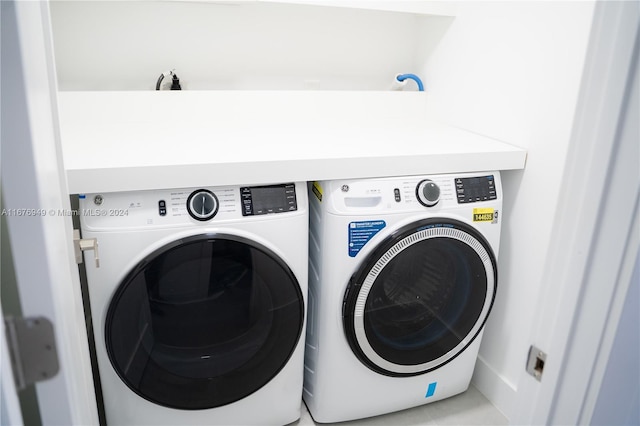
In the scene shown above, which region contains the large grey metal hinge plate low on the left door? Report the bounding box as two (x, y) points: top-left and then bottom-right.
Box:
(4, 316), (60, 390)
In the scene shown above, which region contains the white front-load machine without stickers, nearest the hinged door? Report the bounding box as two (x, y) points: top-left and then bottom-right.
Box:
(79, 182), (308, 425)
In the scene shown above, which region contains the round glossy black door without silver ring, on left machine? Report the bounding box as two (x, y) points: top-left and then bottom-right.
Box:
(105, 234), (304, 409)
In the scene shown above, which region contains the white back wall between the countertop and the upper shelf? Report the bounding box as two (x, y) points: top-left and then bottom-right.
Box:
(51, 1), (440, 90)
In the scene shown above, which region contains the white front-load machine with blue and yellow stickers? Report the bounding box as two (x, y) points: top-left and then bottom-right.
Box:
(303, 171), (503, 423)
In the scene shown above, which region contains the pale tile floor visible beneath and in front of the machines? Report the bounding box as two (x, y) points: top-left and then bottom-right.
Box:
(291, 386), (509, 426)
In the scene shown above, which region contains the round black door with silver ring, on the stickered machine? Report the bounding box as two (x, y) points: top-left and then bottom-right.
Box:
(343, 219), (497, 376)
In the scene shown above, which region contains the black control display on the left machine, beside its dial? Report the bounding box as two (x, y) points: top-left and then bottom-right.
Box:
(240, 183), (298, 216)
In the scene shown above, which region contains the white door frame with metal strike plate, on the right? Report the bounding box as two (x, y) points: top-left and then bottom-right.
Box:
(510, 2), (640, 424)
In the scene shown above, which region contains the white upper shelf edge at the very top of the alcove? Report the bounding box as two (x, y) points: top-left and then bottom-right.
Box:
(164, 0), (457, 16)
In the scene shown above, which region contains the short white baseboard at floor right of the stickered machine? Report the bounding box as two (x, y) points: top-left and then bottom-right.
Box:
(471, 357), (517, 419)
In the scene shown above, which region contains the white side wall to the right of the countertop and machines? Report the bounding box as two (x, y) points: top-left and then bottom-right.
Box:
(422, 2), (594, 416)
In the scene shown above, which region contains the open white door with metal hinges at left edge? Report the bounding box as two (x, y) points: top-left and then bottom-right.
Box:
(0, 1), (98, 425)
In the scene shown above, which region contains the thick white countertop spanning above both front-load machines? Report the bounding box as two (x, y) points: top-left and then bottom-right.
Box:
(59, 91), (526, 193)
